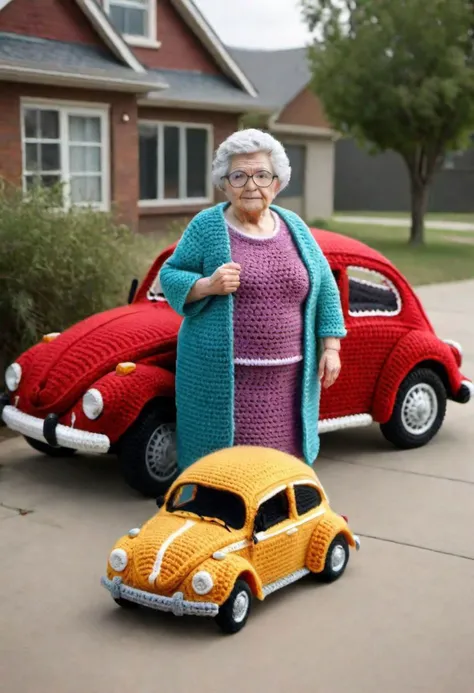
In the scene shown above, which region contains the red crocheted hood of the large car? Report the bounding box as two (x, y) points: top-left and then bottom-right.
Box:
(22, 303), (181, 414)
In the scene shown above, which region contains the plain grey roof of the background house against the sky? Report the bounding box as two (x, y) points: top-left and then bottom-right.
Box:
(228, 47), (311, 111)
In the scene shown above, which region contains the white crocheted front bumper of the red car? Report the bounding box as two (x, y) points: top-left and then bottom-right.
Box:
(2, 404), (110, 452)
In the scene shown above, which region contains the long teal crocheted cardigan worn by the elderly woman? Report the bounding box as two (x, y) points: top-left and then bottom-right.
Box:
(160, 203), (346, 469)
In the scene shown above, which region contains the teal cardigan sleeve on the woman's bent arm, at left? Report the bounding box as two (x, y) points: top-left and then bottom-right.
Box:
(160, 221), (212, 317)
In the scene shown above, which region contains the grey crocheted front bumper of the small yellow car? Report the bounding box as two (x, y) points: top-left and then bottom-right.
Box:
(101, 577), (219, 616)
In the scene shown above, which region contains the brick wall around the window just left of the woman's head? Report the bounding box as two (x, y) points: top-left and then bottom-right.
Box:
(138, 108), (240, 233)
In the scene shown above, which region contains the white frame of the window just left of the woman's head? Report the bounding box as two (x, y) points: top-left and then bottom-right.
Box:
(138, 119), (214, 207)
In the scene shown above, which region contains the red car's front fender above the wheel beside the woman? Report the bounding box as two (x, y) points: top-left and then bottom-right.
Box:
(67, 364), (175, 443)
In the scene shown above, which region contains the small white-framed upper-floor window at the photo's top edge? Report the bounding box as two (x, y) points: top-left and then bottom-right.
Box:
(104, 0), (158, 45)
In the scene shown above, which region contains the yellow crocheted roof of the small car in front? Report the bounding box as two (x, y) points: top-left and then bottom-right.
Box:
(177, 445), (321, 505)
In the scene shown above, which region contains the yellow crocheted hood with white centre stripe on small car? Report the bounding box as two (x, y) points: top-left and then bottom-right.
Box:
(131, 513), (244, 594)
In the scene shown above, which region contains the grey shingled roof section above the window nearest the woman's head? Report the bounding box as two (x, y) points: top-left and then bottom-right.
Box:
(141, 70), (265, 111)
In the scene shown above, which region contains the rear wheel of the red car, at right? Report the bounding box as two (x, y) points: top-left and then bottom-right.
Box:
(380, 368), (447, 450)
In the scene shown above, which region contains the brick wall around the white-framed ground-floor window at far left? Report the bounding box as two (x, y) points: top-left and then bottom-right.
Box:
(0, 82), (138, 229)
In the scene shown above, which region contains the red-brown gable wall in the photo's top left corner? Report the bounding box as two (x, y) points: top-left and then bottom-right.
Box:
(0, 0), (102, 45)
